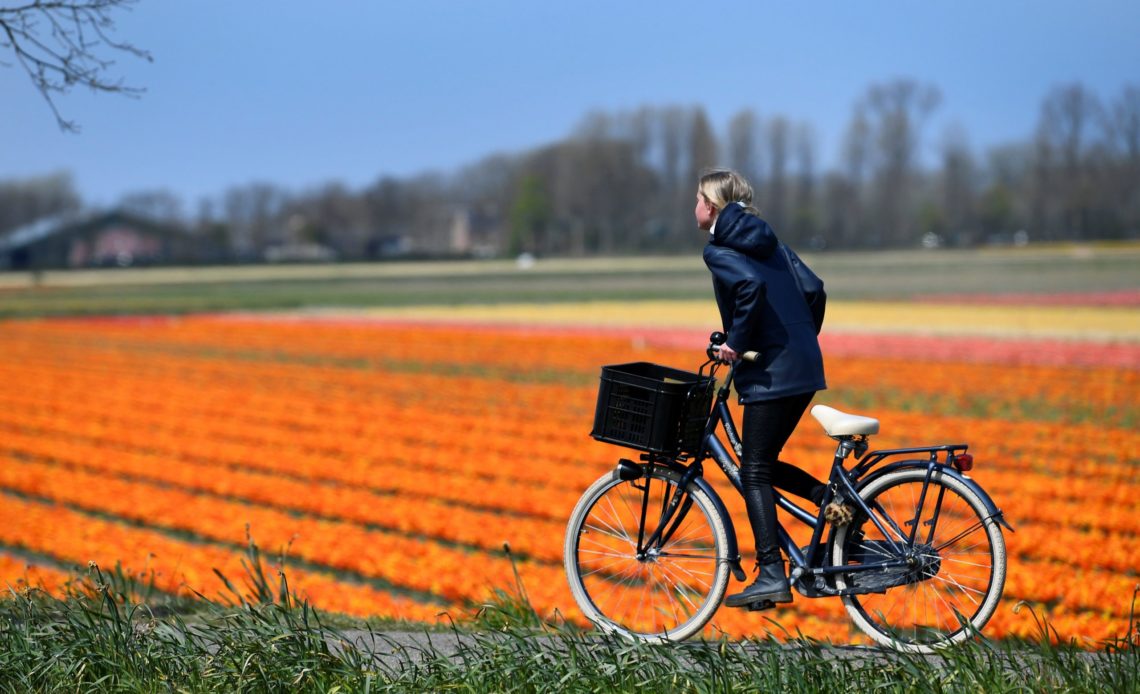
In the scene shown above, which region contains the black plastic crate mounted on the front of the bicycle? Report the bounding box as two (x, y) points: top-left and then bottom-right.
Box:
(591, 361), (716, 456)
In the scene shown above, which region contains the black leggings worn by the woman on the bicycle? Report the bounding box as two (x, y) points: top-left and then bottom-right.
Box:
(740, 393), (824, 564)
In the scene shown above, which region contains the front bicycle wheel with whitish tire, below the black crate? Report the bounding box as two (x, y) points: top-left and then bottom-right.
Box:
(563, 467), (728, 643)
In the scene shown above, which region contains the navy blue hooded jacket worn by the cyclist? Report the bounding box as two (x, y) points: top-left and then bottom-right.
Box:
(705, 204), (828, 405)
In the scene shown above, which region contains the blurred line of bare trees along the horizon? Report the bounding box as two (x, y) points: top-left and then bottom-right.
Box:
(0, 80), (1140, 261)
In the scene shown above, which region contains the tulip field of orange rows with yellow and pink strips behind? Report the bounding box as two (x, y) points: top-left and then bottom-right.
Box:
(0, 254), (1140, 646)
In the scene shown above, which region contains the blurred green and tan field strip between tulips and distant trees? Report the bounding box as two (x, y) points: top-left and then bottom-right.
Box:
(0, 242), (1140, 319)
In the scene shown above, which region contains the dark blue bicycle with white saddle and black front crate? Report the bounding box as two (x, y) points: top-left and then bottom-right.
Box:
(563, 333), (1013, 653)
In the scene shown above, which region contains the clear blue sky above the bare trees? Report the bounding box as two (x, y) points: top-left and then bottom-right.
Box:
(0, 0), (1140, 211)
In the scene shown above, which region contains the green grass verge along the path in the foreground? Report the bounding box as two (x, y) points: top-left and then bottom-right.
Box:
(0, 544), (1140, 694)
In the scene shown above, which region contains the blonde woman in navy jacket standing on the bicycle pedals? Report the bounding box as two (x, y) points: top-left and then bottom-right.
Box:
(694, 170), (827, 607)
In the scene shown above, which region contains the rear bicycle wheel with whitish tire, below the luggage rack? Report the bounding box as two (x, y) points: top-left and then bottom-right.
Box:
(832, 468), (1007, 653)
